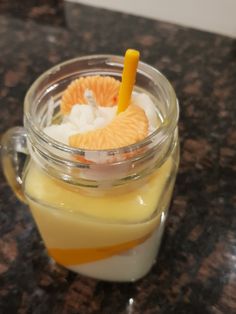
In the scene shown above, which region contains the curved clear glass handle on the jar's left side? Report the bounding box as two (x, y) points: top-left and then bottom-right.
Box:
(1, 127), (28, 203)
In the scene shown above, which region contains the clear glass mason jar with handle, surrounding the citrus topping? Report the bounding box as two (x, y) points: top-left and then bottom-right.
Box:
(1, 55), (179, 281)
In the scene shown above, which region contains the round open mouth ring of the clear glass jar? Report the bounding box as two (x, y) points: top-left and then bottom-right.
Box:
(24, 54), (179, 164)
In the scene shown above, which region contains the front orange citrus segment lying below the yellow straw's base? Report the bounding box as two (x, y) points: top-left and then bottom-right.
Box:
(69, 105), (148, 150)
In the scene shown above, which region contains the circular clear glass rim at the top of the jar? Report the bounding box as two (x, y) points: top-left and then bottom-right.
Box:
(24, 54), (179, 159)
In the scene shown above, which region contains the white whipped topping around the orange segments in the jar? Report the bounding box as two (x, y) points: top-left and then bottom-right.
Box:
(44, 92), (158, 145)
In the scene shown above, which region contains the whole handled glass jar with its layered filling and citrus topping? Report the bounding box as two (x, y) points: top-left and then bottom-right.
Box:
(1, 49), (179, 282)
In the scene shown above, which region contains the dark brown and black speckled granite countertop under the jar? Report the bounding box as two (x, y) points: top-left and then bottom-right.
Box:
(0, 0), (236, 314)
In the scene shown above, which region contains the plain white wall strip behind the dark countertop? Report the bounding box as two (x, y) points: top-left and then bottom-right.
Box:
(68, 0), (236, 38)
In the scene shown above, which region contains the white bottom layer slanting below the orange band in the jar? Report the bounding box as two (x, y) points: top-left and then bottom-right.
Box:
(67, 221), (164, 281)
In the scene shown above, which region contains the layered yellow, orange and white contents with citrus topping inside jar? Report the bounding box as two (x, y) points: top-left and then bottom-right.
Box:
(24, 51), (178, 281)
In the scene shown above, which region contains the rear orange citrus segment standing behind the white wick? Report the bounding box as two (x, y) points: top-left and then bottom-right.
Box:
(61, 75), (120, 114)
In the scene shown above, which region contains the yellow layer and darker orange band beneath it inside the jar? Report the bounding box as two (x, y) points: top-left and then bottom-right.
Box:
(25, 157), (174, 265)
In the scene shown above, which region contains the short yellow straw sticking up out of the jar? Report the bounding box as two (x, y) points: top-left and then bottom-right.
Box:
(117, 49), (140, 113)
